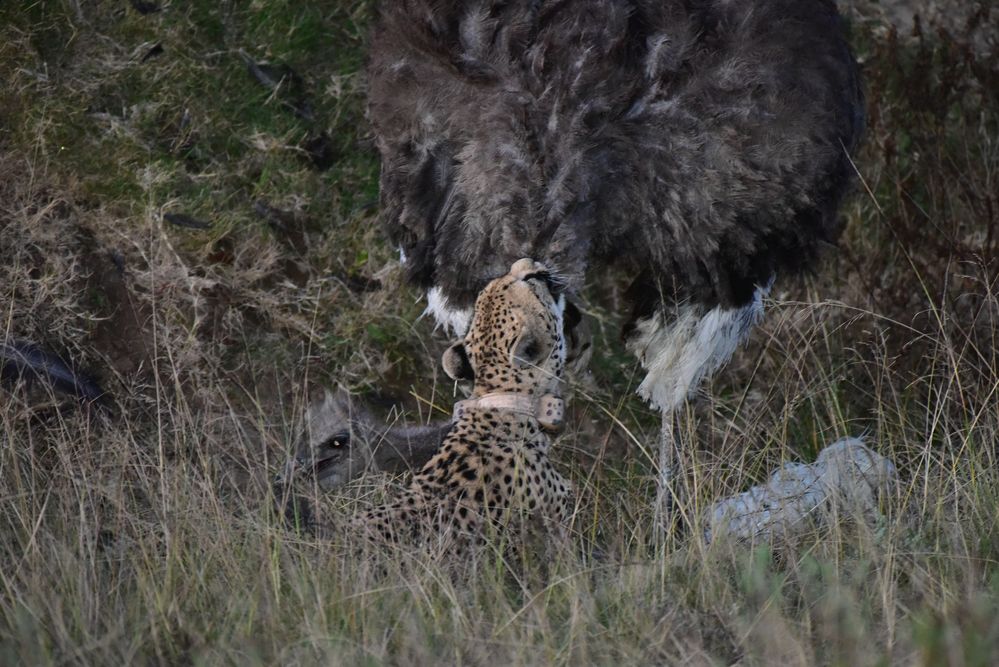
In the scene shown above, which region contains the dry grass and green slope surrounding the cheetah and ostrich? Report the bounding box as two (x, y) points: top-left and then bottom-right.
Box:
(0, 1), (999, 664)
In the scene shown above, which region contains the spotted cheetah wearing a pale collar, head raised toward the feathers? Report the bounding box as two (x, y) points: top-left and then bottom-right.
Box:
(316, 259), (573, 542)
